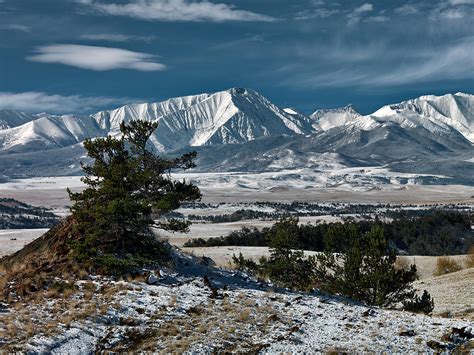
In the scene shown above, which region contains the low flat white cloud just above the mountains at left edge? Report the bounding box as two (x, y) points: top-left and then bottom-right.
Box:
(0, 91), (138, 113)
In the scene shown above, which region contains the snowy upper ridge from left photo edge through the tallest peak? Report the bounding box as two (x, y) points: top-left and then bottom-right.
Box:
(0, 88), (314, 153)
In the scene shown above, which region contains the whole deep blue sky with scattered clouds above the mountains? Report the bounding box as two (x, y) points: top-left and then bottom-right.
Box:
(0, 0), (474, 113)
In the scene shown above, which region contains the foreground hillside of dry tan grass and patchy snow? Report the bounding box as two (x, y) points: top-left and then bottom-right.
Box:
(0, 245), (473, 353)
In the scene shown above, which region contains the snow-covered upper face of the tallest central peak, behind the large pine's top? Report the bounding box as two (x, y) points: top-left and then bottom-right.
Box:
(93, 88), (313, 151)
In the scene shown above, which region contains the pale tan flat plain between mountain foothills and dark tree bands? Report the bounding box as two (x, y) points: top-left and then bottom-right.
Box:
(0, 174), (474, 210)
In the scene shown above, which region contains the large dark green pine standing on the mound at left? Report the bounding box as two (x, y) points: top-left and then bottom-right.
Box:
(68, 121), (201, 270)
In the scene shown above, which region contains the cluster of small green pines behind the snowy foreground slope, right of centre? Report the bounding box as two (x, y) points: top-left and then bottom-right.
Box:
(228, 217), (433, 311)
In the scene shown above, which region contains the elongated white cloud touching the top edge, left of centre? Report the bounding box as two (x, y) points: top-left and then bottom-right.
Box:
(78, 0), (276, 22)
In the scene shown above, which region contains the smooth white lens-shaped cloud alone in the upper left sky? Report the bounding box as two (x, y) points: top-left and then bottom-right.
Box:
(26, 44), (166, 71)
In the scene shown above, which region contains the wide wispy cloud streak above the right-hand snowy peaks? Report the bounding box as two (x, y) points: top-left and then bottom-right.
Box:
(283, 37), (474, 88)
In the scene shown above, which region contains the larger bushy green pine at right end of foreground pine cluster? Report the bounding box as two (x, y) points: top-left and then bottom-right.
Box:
(316, 226), (416, 307)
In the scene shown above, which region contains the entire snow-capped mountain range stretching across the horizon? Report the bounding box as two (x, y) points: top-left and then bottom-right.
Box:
(0, 88), (474, 185)
